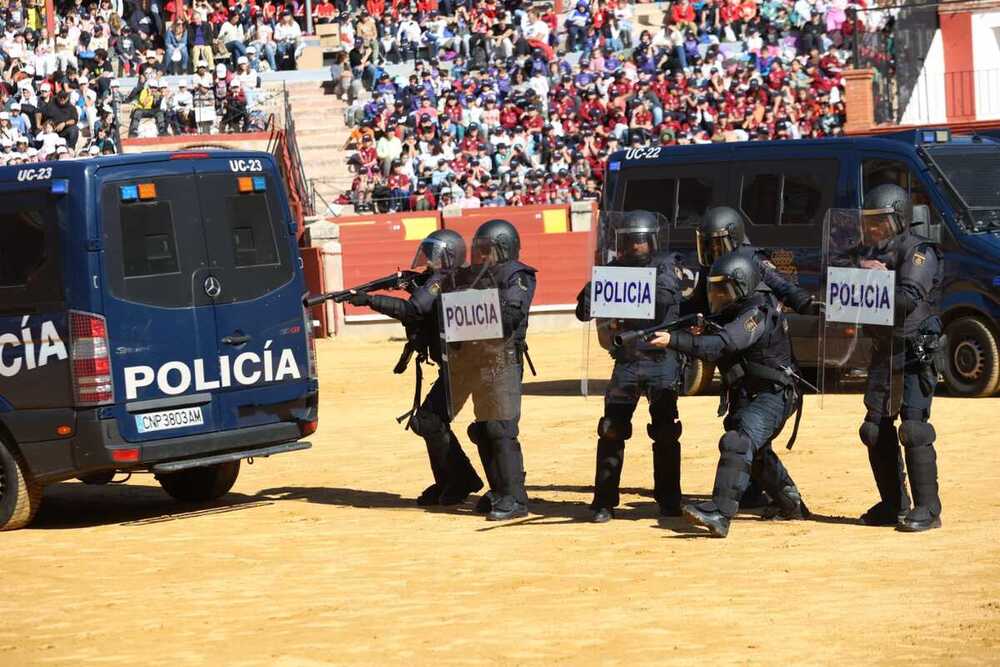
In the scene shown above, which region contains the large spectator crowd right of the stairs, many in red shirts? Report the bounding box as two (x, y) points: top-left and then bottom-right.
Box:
(332, 0), (883, 211)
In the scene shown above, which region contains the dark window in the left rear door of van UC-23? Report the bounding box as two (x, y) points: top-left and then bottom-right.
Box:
(121, 201), (178, 278)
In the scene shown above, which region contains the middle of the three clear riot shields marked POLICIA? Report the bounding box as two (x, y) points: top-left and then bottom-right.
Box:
(580, 211), (670, 396)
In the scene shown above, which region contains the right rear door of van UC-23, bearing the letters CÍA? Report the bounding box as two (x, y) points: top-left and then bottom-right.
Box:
(196, 164), (308, 429)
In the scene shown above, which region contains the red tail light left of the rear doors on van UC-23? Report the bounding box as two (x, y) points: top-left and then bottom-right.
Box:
(69, 310), (115, 406)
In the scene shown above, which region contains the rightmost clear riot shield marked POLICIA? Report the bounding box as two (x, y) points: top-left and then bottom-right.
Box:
(817, 209), (905, 416)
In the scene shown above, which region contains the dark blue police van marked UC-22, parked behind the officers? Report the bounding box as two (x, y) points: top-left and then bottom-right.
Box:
(604, 129), (1000, 396)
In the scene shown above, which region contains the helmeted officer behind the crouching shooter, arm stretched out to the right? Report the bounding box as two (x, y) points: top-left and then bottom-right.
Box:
(696, 206), (819, 314)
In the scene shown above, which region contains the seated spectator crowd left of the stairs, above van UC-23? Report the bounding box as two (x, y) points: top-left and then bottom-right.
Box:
(0, 0), (304, 165)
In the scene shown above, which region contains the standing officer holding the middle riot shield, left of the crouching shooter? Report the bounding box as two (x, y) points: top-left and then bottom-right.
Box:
(576, 211), (682, 523)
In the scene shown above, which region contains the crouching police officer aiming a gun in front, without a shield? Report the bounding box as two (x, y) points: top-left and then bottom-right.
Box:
(651, 253), (802, 537)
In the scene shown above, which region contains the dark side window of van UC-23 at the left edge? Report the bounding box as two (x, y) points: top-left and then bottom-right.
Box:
(0, 192), (62, 306)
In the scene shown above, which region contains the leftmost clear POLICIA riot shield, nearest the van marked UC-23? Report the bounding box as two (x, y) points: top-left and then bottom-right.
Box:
(439, 266), (521, 421)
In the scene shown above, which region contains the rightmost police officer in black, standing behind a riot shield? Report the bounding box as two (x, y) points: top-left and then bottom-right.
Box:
(860, 184), (944, 532)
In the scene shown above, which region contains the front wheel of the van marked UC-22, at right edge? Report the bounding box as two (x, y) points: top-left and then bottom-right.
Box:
(942, 317), (1000, 397)
